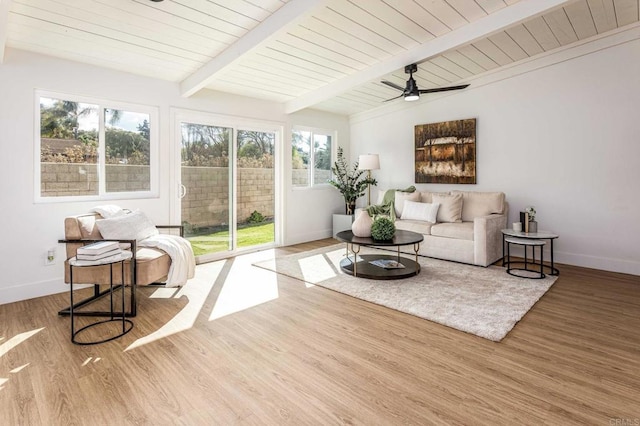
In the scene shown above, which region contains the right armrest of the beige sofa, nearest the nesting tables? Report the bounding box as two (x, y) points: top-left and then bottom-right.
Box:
(473, 214), (507, 266)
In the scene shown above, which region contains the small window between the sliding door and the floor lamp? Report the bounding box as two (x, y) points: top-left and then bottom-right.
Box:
(291, 128), (332, 188)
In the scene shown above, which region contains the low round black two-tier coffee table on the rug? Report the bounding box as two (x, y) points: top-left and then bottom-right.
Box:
(336, 230), (424, 280)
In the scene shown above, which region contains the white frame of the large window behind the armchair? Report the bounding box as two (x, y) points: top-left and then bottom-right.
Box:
(33, 89), (160, 203)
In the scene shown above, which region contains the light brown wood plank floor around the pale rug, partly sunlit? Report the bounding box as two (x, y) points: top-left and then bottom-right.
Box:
(0, 239), (640, 425)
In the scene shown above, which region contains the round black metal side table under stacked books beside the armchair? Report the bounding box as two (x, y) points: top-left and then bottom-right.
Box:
(69, 250), (133, 345)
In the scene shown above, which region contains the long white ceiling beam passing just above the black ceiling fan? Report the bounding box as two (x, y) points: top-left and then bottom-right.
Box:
(285, 0), (573, 114)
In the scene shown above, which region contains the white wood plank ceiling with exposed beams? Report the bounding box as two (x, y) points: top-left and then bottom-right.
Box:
(0, 0), (640, 115)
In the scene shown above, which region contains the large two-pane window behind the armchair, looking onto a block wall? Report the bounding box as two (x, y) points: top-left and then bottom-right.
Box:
(36, 93), (157, 201)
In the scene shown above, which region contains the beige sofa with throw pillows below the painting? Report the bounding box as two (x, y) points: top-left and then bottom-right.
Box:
(384, 191), (508, 266)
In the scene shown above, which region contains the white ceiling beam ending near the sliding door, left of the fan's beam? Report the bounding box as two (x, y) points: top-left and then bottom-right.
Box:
(181, 0), (325, 97)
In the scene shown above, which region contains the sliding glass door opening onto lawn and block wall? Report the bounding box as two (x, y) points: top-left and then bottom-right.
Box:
(176, 111), (280, 262)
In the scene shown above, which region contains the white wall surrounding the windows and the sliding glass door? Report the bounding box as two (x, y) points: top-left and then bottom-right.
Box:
(0, 49), (349, 304)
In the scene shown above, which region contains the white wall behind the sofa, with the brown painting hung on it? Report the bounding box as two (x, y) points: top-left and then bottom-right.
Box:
(351, 27), (640, 275)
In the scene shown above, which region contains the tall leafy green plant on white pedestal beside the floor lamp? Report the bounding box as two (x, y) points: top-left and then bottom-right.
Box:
(329, 147), (378, 214)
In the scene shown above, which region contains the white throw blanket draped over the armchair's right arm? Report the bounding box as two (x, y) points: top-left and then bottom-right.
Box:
(138, 234), (196, 287)
